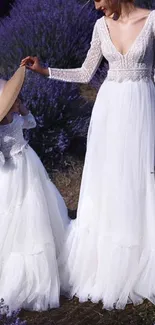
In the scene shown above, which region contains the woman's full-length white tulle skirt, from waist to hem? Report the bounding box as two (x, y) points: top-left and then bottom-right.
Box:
(59, 80), (155, 309)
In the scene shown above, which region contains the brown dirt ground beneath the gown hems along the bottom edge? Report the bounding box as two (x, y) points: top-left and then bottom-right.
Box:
(21, 298), (155, 325)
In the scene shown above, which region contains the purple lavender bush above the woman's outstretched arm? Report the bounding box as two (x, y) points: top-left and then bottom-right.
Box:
(0, 0), (101, 71)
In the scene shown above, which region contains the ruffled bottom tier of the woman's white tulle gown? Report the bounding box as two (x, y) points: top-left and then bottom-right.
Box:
(59, 221), (155, 310)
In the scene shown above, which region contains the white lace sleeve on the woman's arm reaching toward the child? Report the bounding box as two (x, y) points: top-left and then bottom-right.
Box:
(49, 22), (102, 83)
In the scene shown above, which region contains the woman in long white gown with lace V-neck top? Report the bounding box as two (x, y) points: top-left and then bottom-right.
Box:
(21, 0), (155, 309)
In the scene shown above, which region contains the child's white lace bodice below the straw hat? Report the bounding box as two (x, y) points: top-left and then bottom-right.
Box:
(0, 113), (36, 165)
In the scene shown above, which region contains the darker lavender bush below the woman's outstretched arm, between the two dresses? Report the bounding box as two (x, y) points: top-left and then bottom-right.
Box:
(24, 73), (91, 164)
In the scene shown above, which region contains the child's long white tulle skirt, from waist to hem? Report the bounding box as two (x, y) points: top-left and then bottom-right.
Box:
(0, 146), (68, 311)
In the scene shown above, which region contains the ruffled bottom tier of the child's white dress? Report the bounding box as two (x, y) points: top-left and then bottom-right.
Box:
(0, 244), (60, 311)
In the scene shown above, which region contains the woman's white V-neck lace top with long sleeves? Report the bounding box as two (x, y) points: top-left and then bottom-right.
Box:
(49, 10), (155, 83)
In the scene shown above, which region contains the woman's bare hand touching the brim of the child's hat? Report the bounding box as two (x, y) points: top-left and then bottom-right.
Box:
(20, 56), (49, 76)
